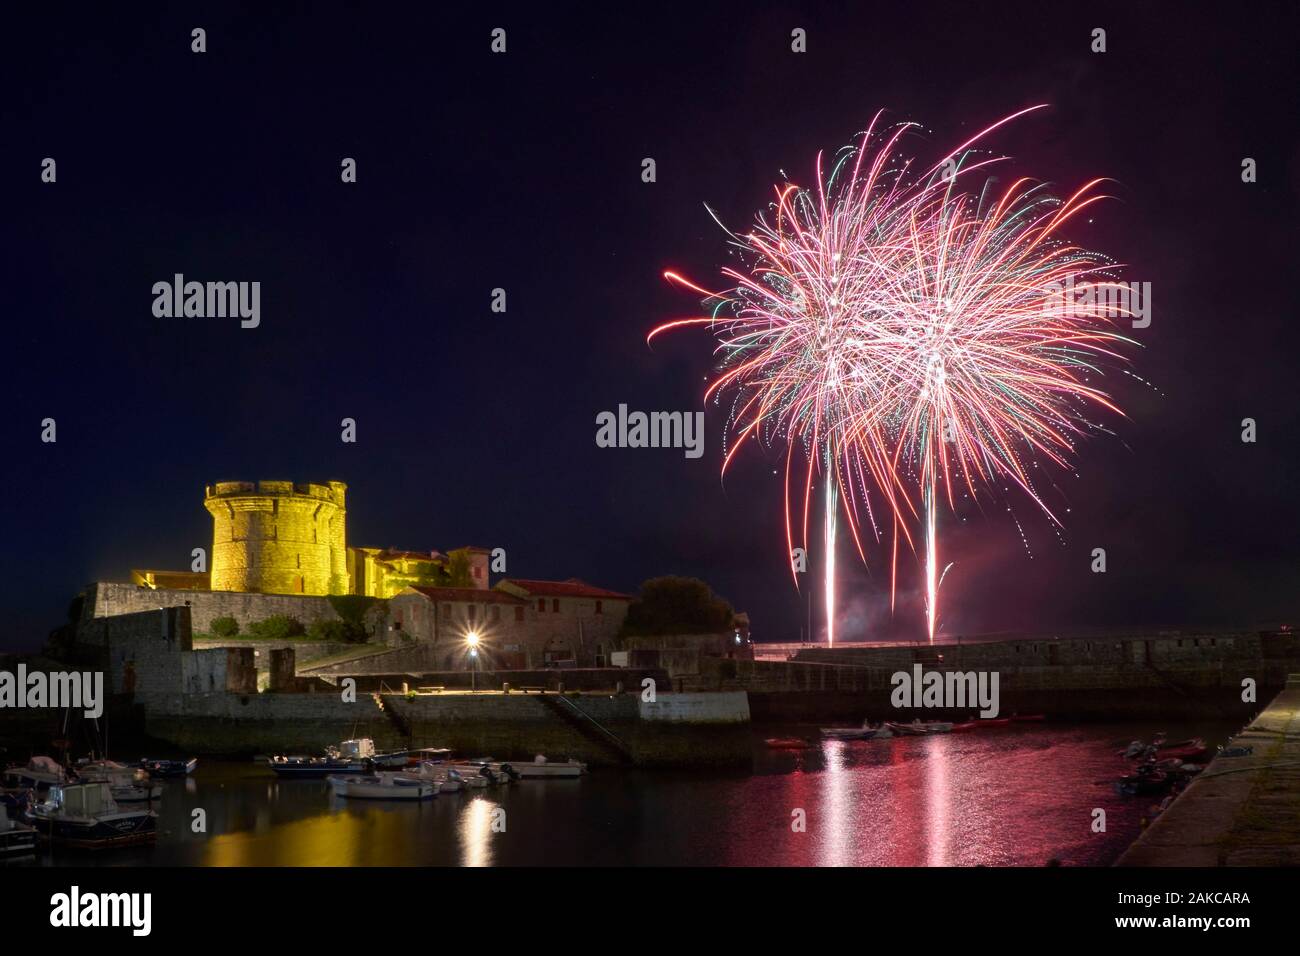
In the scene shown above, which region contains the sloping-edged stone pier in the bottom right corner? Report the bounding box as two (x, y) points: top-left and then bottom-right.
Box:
(1115, 674), (1300, 866)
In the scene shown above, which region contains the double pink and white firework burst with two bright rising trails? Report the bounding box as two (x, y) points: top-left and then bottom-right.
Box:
(647, 107), (1130, 641)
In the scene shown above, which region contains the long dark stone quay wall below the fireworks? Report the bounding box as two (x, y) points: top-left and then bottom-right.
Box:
(671, 632), (1300, 722)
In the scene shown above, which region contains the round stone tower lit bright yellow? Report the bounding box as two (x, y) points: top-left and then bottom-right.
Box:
(203, 481), (348, 594)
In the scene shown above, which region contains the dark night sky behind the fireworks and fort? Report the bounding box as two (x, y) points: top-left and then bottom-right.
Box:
(0, 3), (1300, 648)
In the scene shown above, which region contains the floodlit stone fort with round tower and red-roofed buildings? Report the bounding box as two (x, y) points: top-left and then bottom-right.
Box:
(81, 481), (632, 669)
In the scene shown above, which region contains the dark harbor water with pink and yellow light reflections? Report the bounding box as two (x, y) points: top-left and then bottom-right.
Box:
(17, 723), (1236, 866)
